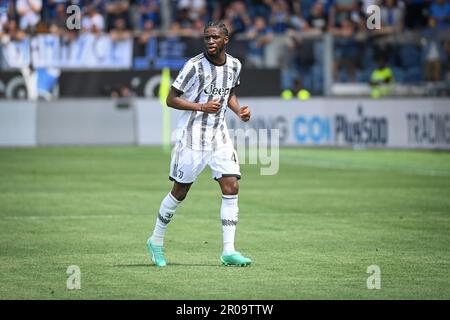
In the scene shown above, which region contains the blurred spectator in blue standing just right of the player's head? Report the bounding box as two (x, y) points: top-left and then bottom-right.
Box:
(247, 16), (273, 68)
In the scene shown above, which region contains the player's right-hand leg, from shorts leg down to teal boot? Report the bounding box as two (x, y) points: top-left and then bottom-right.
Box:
(210, 147), (251, 266)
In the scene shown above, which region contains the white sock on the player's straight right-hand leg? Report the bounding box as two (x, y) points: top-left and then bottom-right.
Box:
(220, 194), (239, 255)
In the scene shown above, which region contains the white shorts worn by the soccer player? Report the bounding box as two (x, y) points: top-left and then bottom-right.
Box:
(169, 142), (241, 183)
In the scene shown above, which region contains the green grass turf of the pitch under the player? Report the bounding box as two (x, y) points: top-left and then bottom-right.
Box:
(0, 147), (450, 299)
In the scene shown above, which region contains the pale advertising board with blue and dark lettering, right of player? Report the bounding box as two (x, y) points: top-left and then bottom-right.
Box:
(229, 99), (450, 149)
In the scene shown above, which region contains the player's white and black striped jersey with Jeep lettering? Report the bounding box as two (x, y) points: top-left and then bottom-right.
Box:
(172, 53), (242, 150)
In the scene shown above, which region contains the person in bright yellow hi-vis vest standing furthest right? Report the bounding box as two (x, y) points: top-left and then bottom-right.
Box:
(370, 55), (395, 98)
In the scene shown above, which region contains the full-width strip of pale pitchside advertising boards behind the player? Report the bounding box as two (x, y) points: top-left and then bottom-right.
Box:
(0, 98), (450, 150)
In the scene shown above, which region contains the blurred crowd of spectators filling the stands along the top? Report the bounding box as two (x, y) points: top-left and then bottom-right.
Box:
(0, 0), (450, 92)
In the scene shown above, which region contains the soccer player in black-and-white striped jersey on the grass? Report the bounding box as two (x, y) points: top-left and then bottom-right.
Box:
(147, 22), (251, 267)
